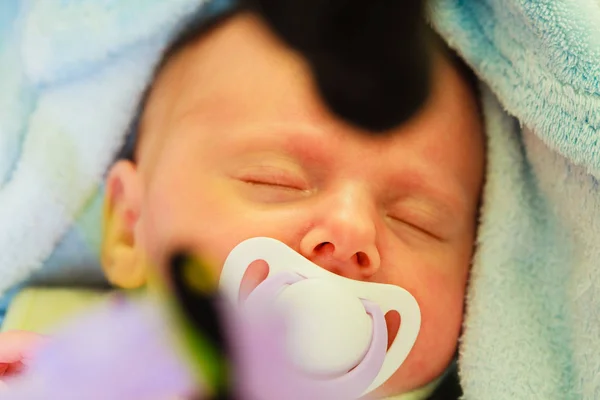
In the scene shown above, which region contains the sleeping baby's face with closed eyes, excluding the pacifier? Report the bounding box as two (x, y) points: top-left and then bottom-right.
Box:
(104, 12), (484, 394)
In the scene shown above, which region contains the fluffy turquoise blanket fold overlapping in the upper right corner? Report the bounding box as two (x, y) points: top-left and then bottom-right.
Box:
(431, 0), (600, 176)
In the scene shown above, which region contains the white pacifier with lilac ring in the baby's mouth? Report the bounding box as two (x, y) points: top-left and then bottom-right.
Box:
(220, 237), (421, 398)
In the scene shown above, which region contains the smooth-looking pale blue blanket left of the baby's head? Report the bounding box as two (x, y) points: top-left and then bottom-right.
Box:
(0, 0), (239, 302)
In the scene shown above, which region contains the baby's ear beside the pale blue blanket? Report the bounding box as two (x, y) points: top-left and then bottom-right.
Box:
(101, 161), (147, 289)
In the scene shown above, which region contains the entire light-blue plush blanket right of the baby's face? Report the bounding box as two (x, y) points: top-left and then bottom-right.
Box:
(431, 0), (600, 400)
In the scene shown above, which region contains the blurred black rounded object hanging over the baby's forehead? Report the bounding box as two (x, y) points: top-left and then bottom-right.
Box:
(242, 0), (430, 133)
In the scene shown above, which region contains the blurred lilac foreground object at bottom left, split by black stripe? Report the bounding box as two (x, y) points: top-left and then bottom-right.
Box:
(0, 294), (372, 400)
